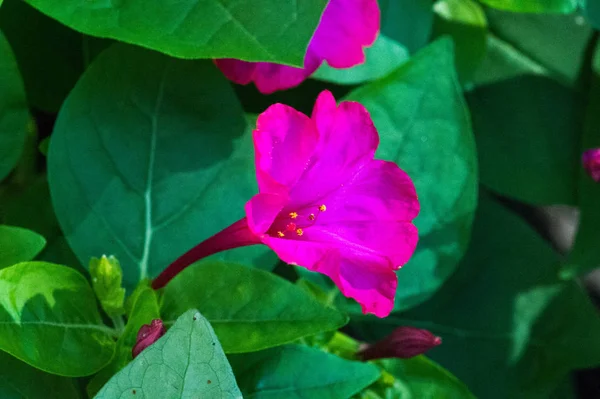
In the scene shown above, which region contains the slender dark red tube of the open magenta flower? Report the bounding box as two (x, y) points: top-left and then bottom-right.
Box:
(152, 218), (261, 290)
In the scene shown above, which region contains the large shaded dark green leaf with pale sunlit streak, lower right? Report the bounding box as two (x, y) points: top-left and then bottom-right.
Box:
(354, 196), (600, 399)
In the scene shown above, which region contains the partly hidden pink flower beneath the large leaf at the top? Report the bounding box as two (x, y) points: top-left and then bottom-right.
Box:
(215, 0), (379, 94)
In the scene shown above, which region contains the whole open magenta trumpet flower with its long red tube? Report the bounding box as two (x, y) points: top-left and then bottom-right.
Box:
(153, 91), (419, 317)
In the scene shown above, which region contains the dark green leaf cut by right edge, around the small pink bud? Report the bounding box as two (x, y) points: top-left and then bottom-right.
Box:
(561, 44), (600, 278)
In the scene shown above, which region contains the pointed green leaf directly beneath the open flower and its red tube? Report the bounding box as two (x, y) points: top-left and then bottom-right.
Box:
(161, 261), (347, 353)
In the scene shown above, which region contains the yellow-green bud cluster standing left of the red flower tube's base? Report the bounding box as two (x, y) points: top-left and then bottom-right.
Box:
(90, 255), (125, 317)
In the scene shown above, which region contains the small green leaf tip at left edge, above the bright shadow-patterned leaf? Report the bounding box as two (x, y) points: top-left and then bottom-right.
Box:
(0, 225), (46, 269)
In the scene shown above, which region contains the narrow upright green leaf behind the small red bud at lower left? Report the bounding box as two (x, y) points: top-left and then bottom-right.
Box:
(87, 282), (160, 398)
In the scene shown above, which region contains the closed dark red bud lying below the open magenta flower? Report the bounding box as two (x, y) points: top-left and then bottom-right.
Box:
(358, 327), (442, 360)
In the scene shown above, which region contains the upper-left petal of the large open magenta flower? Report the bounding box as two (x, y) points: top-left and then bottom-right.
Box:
(253, 104), (319, 192)
